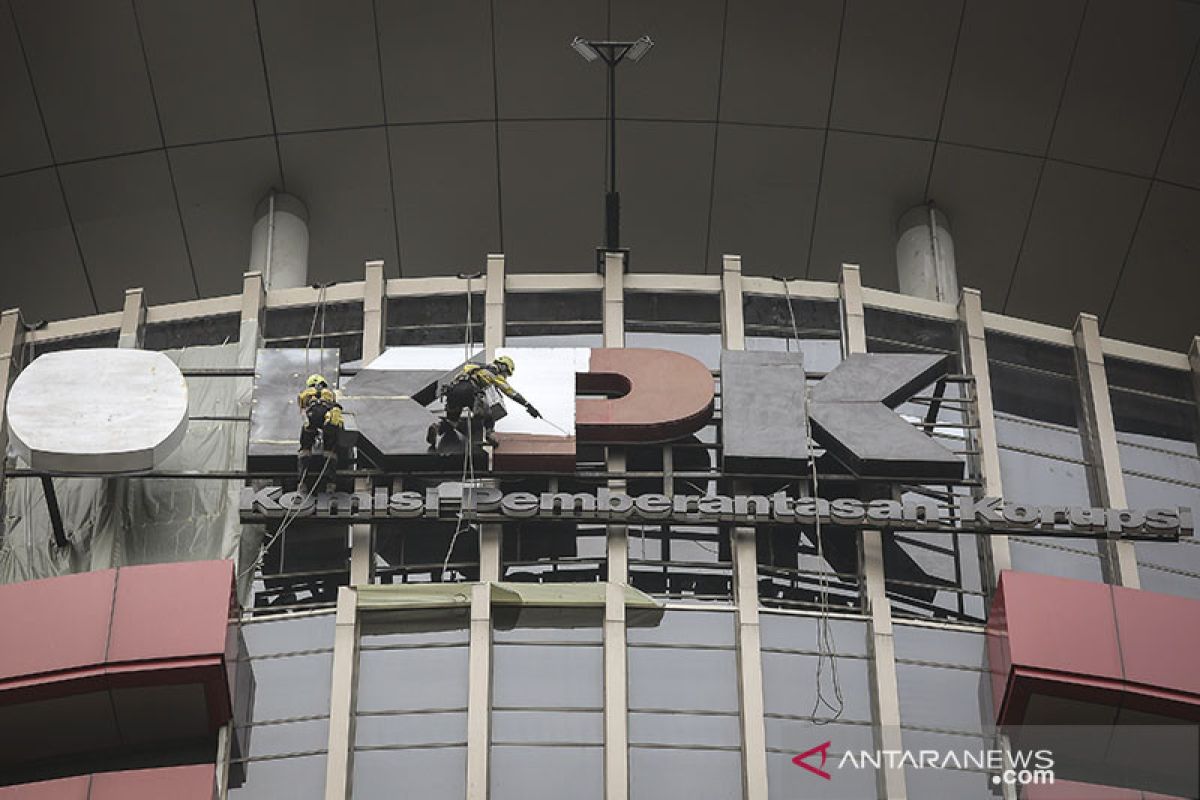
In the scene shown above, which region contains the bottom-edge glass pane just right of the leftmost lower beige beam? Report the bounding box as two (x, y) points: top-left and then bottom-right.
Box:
(350, 747), (467, 800)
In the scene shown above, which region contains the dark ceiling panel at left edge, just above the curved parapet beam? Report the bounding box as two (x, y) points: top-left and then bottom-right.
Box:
(0, 169), (96, 323)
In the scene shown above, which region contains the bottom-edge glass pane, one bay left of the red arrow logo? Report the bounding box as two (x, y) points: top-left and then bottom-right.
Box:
(629, 747), (742, 800)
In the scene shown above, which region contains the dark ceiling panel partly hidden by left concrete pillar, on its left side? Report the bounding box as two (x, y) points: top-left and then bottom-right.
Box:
(170, 137), (280, 296)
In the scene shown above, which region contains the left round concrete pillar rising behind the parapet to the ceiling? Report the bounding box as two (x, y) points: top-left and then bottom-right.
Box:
(250, 192), (308, 289)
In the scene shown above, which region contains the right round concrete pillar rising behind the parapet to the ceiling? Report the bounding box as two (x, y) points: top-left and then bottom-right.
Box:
(896, 204), (959, 302)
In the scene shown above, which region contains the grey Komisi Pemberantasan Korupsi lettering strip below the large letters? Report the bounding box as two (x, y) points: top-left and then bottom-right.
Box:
(241, 483), (1194, 541)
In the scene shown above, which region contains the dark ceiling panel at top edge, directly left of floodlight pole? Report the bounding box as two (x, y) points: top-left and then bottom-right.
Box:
(494, 0), (609, 120)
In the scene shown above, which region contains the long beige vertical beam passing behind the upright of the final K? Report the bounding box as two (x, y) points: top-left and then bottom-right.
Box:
(721, 255), (768, 800)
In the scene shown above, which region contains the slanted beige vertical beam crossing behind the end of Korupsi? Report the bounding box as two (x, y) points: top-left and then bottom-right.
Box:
(1072, 314), (1141, 589)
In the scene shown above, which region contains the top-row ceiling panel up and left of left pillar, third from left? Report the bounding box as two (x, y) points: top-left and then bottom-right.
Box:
(137, 0), (271, 144)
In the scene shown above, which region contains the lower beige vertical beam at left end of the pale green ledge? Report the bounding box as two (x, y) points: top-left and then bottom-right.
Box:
(325, 587), (359, 800)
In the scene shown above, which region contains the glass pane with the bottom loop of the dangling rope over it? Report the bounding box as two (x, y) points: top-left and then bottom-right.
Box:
(762, 652), (871, 722)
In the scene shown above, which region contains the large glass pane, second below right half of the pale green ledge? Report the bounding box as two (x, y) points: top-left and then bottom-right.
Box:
(492, 644), (604, 708)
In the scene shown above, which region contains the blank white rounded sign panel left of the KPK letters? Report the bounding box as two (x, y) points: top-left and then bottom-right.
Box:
(7, 349), (187, 475)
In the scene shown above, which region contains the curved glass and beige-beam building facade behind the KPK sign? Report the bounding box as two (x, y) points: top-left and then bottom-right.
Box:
(0, 254), (1200, 800)
